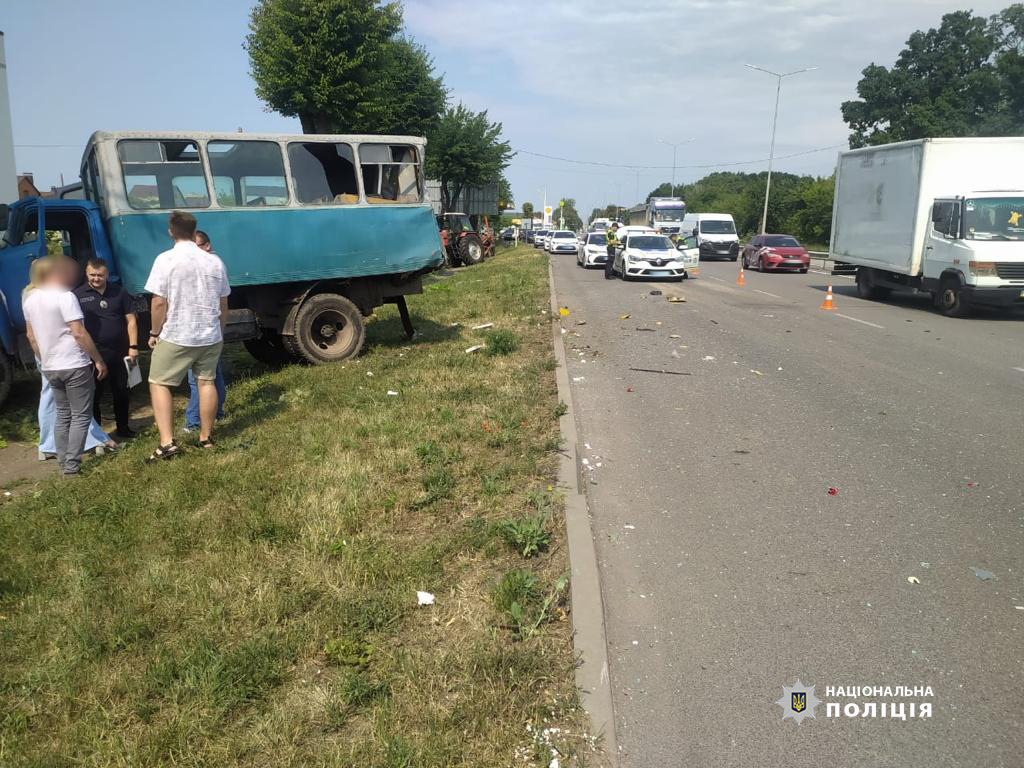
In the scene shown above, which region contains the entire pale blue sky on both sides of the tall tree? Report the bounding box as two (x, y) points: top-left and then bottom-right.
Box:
(0, 0), (1010, 215)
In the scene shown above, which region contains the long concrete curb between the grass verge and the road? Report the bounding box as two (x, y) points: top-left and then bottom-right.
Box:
(548, 260), (618, 768)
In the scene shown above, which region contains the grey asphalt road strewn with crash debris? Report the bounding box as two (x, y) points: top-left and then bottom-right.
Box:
(553, 256), (1024, 768)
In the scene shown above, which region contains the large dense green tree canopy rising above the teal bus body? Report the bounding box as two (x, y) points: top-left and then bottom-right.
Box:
(245, 0), (447, 135)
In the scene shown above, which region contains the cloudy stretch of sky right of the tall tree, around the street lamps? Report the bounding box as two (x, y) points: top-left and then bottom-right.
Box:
(406, 0), (1009, 217)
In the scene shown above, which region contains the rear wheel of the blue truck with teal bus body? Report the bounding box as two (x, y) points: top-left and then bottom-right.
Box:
(283, 293), (367, 365)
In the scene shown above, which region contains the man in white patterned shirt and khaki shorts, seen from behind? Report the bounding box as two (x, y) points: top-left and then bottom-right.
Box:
(145, 211), (231, 461)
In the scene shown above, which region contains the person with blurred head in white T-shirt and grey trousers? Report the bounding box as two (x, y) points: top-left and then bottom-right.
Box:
(23, 256), (106, 475)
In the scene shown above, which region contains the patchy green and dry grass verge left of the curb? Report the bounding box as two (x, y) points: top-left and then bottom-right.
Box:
(0, 248), (590, 768)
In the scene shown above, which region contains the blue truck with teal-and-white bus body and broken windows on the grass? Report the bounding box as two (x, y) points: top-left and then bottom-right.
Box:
(0, 132), (443, 402)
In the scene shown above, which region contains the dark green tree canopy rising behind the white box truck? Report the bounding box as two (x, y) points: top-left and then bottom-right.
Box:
(842, 3), (1024, 147)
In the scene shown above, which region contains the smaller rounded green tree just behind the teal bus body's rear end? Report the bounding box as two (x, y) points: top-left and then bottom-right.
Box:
(427, 103), (514, 211)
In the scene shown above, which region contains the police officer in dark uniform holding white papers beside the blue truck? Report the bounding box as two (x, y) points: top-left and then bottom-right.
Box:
(75, 258), (138, 440)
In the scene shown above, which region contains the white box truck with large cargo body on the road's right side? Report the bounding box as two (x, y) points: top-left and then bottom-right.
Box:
(828, 137), (1024, 317)
